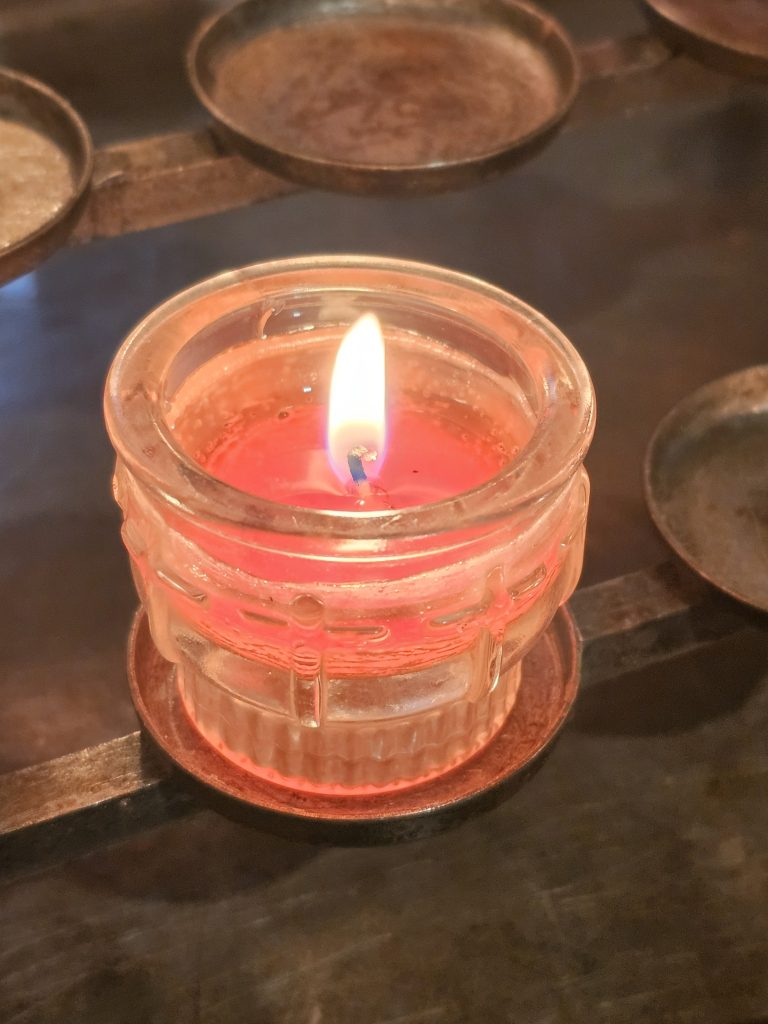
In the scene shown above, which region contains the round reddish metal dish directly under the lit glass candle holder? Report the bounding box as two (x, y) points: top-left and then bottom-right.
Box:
(128, 609), (580, 844)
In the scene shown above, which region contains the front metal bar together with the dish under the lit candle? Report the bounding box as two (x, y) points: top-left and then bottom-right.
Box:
(0, 563), (757, 874)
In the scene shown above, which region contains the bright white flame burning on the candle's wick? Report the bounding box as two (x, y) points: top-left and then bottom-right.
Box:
(328, 313), (386, 483)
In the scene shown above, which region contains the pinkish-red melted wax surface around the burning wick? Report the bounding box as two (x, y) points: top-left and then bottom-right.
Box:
(199, 404), (514, 511)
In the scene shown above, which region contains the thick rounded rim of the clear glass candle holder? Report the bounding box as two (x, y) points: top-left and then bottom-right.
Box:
(104, 254), (595, 541)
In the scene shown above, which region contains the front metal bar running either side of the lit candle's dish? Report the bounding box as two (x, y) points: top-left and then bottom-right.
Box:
(0, 563), (768, 878)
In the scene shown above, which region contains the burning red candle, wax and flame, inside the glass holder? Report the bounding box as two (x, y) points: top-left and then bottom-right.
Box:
(195, 305), (514, 512)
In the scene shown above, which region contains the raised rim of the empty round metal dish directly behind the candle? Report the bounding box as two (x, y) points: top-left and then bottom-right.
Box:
(185, 0), (582, 195)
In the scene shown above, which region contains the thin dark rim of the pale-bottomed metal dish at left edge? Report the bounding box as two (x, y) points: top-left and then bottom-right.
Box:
(0, 67), (94, 284)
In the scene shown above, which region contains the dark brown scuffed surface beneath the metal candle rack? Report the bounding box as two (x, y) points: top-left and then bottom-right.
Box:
(0, 0), (768, 1024)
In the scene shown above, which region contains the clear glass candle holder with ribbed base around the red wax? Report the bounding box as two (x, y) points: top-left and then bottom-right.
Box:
(105, 256), (594, 795)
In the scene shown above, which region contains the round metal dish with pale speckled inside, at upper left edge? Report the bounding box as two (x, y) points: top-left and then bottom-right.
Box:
(0, 68), (93, 284)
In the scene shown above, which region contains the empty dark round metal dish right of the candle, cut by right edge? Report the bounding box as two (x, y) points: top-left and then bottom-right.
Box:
(645, 366), (768, 611)
